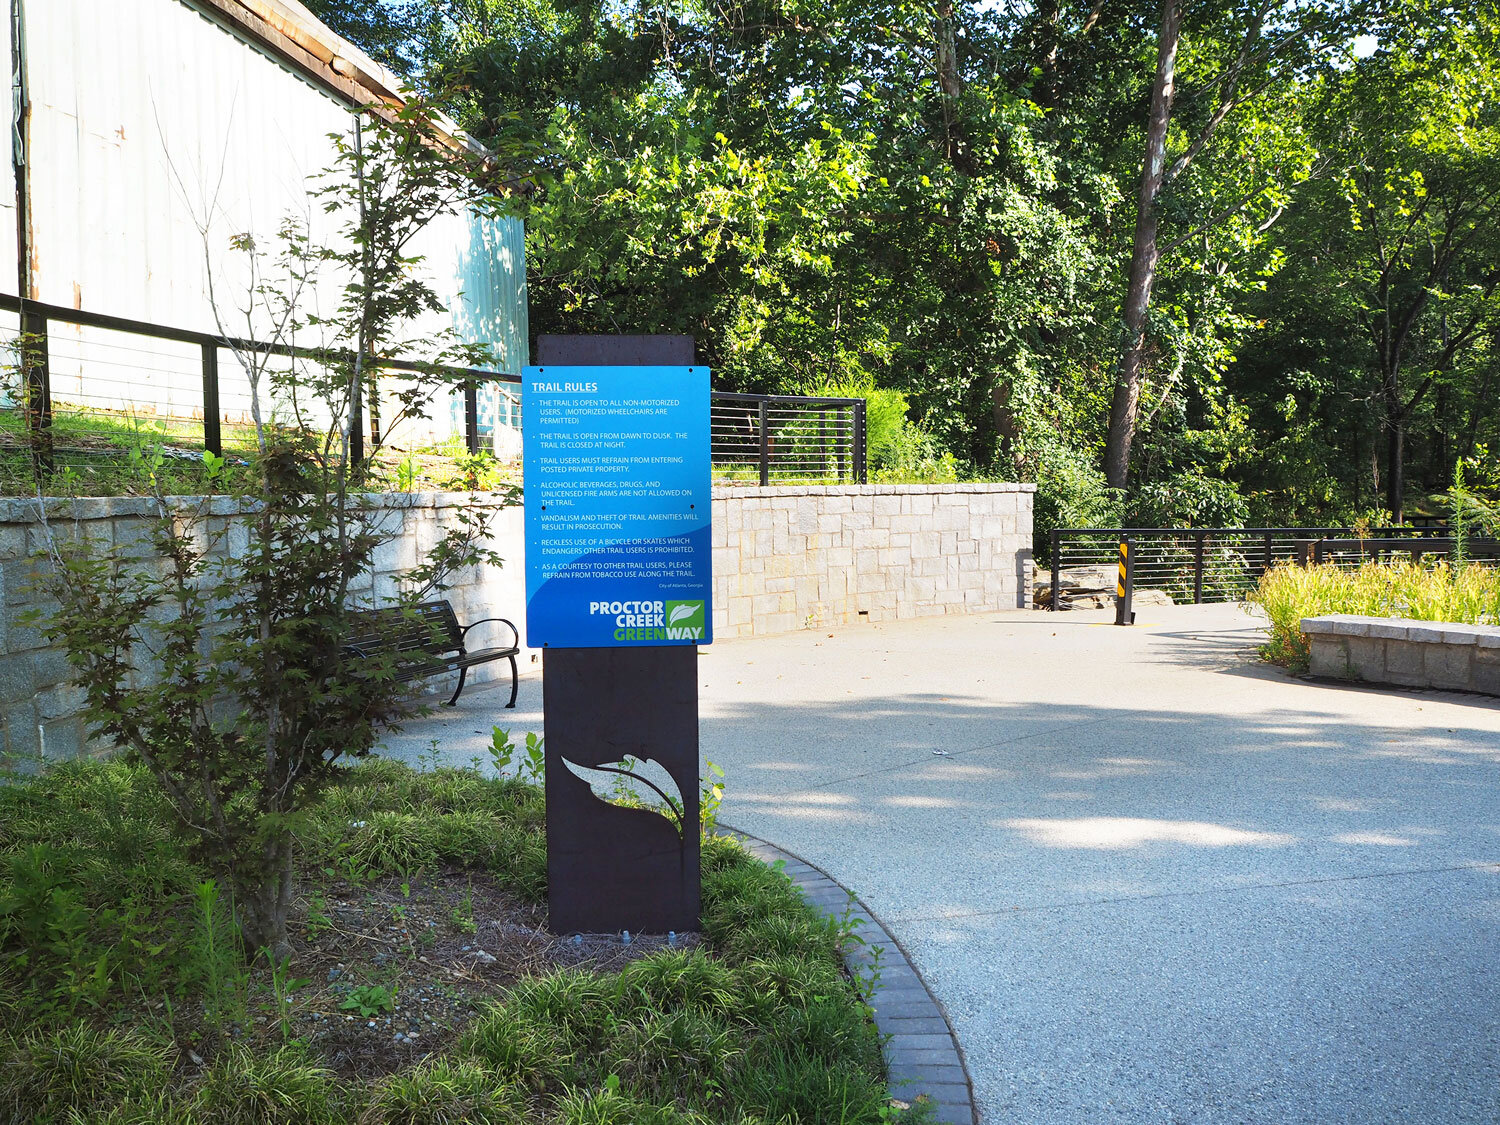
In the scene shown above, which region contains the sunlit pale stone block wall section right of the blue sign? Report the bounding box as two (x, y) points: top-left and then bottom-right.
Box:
(714, 485), (1035, 638)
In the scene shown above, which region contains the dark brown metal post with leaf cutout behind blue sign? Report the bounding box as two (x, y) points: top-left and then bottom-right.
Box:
(534, 336), (711, 933)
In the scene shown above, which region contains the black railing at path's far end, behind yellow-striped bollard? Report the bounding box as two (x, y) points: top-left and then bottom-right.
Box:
(1049, 527), (1449, 609)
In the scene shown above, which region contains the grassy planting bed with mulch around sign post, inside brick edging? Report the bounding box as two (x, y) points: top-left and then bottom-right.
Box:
(0, 761), (897, 1125)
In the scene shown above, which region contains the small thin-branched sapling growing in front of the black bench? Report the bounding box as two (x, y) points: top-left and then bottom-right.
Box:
(36, 107), (515, 960)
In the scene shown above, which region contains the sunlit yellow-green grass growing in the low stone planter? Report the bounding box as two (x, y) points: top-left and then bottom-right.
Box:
(1247, 561), (1500, 671)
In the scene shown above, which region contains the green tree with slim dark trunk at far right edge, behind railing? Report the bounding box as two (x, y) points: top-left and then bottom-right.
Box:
(1326, 26), (1500, 522)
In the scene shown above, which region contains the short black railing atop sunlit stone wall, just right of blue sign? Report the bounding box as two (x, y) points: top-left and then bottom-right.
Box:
(710, 392), (867, 485)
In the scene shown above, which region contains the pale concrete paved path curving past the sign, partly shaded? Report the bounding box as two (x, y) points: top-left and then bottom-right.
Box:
(381, 606), (1500, 1125)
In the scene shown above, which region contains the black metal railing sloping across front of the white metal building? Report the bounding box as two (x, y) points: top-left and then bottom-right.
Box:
(0, 294), (521, 480)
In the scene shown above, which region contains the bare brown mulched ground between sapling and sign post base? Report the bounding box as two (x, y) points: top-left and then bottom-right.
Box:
(177, 870), (698, 1080)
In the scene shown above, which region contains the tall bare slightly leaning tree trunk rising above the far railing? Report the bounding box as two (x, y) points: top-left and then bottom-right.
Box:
(1104, 0), (1182, 489)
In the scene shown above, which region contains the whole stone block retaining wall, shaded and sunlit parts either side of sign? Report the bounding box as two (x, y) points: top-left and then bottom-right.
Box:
(0, 485), (1034, 758)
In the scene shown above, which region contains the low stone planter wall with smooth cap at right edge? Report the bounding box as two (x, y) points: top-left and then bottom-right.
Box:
(1302, 614), (1500, 696)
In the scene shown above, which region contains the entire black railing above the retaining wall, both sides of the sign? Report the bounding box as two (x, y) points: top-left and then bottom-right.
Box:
(0, 294), (867, 485)
